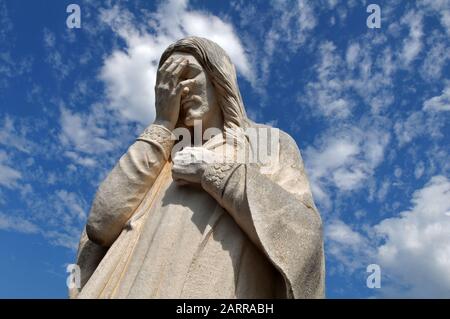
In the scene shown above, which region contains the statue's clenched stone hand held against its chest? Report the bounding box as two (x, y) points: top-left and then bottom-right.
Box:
(172, 147), (217, 185)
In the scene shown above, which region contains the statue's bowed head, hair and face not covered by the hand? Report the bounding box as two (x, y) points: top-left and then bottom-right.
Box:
(159, 37), (249, 128)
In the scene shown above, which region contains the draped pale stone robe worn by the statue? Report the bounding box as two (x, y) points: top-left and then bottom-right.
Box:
(70, 125), (324, 298)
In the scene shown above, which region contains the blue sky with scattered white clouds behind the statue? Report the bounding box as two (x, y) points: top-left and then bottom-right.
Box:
(0, 0), (450, 298)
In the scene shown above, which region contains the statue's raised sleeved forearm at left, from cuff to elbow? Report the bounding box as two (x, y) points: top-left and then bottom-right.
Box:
(86, 125), (174, 247)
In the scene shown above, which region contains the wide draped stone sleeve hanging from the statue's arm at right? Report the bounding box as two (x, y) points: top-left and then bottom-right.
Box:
(202, 133), (325, 298)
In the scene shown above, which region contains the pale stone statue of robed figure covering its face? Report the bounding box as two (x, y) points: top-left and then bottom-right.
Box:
(69, 37), (325, 298)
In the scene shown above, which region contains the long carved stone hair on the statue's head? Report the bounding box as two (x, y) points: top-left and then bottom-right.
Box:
(159, 37), (250, 129)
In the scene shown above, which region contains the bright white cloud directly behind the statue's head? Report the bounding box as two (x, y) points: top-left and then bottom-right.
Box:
(100, 0), (253, 125)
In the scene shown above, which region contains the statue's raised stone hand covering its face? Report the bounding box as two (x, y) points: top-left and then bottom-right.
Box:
(154, 57), (193, 130)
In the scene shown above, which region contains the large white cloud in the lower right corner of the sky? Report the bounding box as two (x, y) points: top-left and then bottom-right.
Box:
(375, 176), (450, 298)
